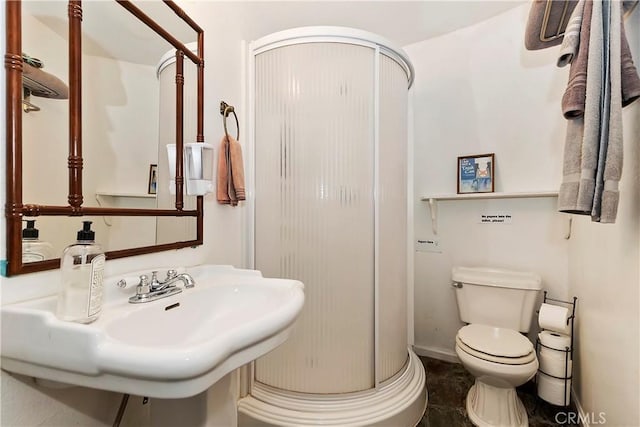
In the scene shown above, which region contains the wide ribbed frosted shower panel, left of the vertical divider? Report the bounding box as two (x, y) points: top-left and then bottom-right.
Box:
(255, 43), (375, 393)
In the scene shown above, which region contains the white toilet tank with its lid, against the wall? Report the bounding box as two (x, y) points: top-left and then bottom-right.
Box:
(451, 267), (542, 332)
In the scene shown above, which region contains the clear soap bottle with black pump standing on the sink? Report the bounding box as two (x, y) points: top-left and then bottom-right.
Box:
(57, 221), (105, 323)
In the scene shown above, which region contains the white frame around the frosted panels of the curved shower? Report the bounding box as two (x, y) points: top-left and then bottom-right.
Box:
(240, 27), (415, 398)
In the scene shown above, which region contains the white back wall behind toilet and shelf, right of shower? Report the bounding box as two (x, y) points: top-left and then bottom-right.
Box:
(405, 5), (568, 358)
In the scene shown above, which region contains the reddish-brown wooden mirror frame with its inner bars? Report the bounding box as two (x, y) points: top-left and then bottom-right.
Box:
(4, 0), (204, 276)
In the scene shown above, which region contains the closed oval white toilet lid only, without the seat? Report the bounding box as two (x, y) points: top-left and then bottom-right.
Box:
(458, 324), (533, 358)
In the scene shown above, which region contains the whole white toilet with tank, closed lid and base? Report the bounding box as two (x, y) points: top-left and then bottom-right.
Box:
(451, 267), (541, 427)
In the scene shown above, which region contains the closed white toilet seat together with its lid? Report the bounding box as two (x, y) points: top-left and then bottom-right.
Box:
(456, 324), (536, 365)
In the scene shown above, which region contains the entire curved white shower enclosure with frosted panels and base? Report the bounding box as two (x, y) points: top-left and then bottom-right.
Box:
(239, 27), (426, 426)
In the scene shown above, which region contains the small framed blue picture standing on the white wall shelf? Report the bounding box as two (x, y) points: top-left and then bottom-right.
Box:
(458, 153), (496, 194)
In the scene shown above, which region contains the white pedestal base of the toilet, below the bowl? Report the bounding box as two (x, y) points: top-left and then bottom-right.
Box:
(467, 379), (529, 427)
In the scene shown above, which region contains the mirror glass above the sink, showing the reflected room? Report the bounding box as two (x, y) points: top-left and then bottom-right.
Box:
(22, 1), (197, 262)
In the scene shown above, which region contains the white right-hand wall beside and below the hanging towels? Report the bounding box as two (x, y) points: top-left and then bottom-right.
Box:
(569, 19), (640, 426)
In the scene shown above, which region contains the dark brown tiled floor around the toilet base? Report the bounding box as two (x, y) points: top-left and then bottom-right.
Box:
(418, 357), (575, 427)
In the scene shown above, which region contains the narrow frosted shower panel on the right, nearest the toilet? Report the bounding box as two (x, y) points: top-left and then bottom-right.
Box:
(377, 55), (409, 382)
